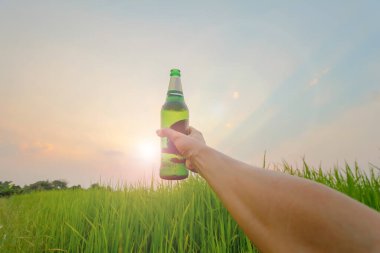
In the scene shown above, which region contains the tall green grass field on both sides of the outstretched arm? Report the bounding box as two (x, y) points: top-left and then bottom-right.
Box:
(0, 163), (380, 253)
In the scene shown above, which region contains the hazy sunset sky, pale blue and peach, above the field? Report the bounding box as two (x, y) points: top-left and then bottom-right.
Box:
(0, 0), (380, 186)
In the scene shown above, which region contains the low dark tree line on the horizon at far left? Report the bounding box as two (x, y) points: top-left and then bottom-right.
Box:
(0, 180), (102, 198)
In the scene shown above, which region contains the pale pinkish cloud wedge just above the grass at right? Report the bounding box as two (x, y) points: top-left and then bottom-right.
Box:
(266, 99), (380, 169)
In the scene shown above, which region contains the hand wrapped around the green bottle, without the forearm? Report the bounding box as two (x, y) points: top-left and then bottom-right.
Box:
(157, 127), (206, 172)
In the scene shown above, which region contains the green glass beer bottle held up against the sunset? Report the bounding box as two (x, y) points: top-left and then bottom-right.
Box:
(160, 69), (189, 180)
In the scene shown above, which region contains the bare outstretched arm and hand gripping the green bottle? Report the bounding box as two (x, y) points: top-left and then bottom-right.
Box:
(157, 127), (380, 253)
